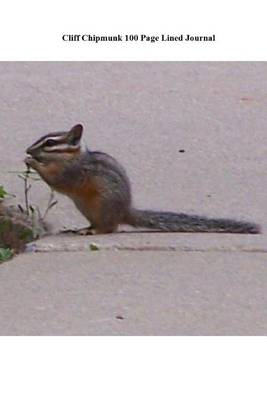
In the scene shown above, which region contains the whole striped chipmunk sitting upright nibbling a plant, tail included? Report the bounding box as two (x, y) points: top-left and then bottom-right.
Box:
(25, 124), (260, 234)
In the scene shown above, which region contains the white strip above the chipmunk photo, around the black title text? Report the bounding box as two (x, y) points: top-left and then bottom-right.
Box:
(0, 0), (266, 61)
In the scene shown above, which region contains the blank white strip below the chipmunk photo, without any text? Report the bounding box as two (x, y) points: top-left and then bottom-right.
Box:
(0, 337), (267, 400)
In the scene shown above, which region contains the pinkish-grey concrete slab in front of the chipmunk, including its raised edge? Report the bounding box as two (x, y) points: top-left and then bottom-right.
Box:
(0, 233), (267, 335)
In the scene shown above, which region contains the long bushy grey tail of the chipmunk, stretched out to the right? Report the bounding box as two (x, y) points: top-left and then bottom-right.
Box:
(125, 209), (261, 234)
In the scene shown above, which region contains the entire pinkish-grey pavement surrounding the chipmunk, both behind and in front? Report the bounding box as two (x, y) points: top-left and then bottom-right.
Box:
(0, 62), (267, 335)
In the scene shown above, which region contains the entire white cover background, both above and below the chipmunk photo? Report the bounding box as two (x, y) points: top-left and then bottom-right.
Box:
(0, 0), (267, 400)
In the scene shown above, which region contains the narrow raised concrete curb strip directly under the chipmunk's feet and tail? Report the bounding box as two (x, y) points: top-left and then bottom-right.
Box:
(27, 232), (267, 253)
